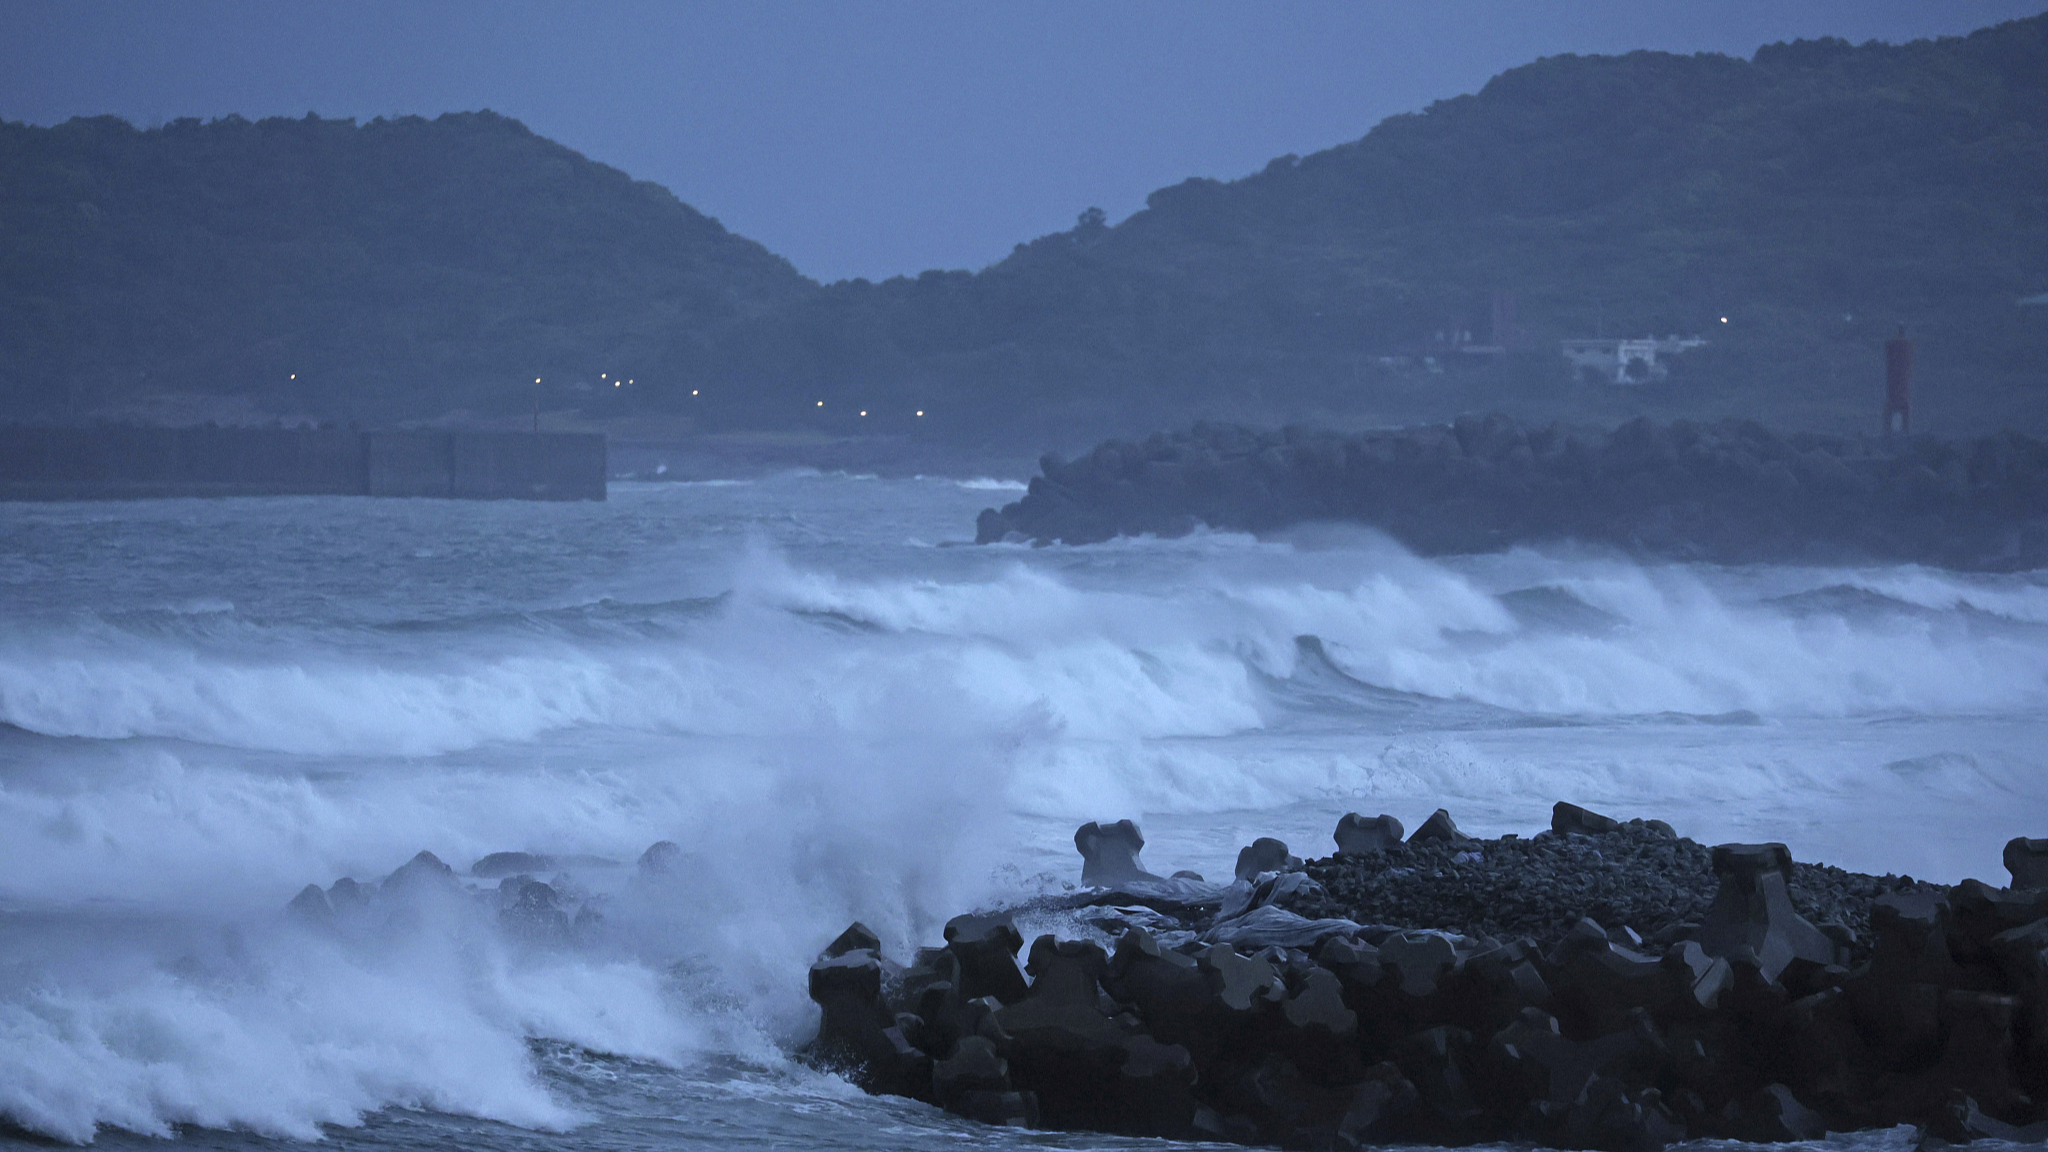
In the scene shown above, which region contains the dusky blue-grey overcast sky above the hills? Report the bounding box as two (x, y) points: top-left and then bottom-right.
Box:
(0, 0), (2048, 281)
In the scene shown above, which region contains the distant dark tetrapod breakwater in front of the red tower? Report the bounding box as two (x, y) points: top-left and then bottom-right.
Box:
(975, 416), (2048, 570)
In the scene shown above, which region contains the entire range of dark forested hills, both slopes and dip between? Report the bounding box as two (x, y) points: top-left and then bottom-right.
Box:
(0, 16), (2048, 449)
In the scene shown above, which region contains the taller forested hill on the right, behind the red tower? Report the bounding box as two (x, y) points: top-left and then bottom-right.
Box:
(678, 16), (2048, 447)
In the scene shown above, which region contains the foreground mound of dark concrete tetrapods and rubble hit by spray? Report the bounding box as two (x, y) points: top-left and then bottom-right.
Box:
(809, 804), (2048, 1150)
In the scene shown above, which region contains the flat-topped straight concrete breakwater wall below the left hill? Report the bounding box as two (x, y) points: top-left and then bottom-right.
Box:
(0, 426), (604, 500)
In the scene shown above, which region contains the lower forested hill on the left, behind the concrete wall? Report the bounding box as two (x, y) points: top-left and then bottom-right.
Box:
(0, 113), (815, 420)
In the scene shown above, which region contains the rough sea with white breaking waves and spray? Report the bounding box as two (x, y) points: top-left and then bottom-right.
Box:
(0, 474), (2048, 1148)
